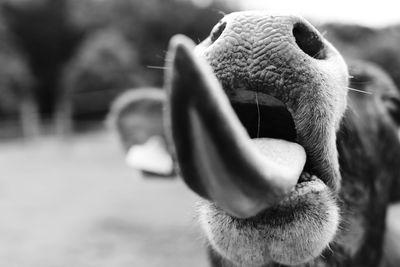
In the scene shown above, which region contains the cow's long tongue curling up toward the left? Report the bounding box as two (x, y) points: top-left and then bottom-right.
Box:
(165, 36), (306, 218)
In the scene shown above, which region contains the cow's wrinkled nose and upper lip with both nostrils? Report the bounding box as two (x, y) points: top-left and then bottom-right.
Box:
(195, 11), (348, 191)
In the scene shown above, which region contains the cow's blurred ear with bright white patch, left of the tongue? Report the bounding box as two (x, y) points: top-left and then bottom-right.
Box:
(108, 88), (174, 177)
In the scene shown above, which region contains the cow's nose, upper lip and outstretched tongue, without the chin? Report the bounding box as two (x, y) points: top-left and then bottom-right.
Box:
(165, 12), (348, 218)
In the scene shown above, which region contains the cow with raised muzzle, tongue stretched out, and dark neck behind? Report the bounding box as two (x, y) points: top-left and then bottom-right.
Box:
(111, 12), (400, 266)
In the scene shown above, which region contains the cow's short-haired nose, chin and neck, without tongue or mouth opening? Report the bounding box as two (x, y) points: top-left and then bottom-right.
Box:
(189, 12), (400, 266)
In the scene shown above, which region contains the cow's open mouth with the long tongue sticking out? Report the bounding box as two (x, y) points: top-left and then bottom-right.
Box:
(166, 37), (325, 218)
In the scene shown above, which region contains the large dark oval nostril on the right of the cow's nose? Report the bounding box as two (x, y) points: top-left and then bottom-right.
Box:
(293, 23), (326, 59)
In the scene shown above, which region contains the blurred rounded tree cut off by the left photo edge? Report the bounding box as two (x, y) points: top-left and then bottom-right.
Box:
(0, 15), (40, 138)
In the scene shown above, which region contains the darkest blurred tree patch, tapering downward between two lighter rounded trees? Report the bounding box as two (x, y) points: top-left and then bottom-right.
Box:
(2, 0), (82, 119)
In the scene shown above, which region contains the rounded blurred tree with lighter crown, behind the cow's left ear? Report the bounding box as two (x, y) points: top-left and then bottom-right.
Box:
(59, 28), (144, 131)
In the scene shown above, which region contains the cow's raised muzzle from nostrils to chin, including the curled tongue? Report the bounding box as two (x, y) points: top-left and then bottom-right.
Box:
(166, 11), (352, 266)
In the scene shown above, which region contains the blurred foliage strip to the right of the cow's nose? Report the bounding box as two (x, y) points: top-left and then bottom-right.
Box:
(321, 24), (400, 93)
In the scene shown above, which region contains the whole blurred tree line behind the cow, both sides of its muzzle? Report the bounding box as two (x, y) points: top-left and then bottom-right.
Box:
(0, 0), (400, 133)
